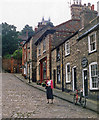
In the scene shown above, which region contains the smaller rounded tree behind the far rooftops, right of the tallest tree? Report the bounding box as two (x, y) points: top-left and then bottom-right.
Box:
(21, 25), (34, 37)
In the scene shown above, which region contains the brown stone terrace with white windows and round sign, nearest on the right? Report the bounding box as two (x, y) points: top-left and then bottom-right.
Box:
(51, 14), (99, 98)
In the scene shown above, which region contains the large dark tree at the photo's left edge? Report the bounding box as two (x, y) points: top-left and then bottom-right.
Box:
(2, 23), (19, 56)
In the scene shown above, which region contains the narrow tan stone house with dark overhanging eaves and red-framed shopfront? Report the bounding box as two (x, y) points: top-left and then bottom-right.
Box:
(34, 18), (54, 82)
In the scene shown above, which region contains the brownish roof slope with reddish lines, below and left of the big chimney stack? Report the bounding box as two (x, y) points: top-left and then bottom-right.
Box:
(52, 19), (81, 48)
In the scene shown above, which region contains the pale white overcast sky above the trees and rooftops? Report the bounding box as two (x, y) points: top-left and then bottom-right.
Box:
(0, 0), (99, 31)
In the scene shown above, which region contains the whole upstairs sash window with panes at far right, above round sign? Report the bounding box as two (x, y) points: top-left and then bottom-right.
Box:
(88, 32), (96, 53)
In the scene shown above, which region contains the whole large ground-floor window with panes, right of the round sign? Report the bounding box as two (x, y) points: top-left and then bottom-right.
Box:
(89, 62), (98, 90)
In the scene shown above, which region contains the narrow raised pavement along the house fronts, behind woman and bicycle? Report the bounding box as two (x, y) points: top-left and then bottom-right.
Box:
(14, 74), (99, 114)
